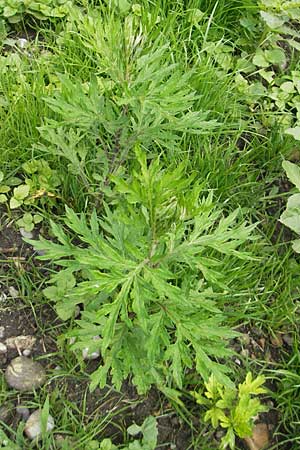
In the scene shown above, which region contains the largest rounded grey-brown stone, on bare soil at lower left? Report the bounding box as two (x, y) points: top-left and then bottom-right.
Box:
(5, 356), (46, 391)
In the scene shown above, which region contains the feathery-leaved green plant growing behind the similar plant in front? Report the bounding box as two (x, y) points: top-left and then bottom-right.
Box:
(36, 9), (220, 193)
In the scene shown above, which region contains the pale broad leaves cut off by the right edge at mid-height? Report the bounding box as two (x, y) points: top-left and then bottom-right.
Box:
(280, 161), (300, 253)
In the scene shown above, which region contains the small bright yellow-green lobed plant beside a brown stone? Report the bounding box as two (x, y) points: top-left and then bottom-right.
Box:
(193, 373), (267, 450)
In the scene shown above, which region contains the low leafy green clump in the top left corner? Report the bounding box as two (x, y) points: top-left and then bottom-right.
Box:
(0, 0), (74, 23)
